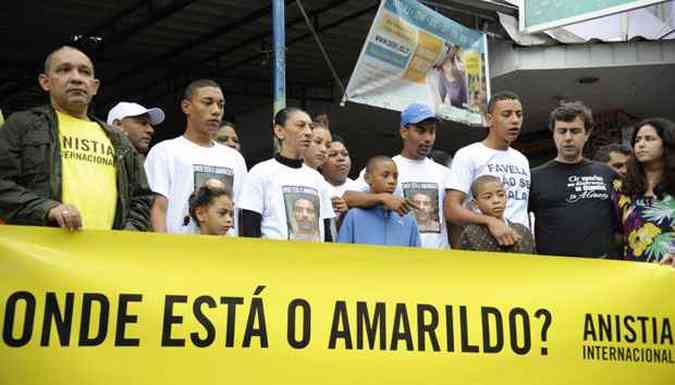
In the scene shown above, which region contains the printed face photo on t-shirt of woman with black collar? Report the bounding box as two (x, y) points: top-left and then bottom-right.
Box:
(282, 186), (321, 241)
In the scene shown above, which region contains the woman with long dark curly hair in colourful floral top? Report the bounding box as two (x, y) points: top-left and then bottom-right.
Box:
(614, 118), (675, 265)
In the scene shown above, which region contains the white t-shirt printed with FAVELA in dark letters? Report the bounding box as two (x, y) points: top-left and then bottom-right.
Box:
(450, 142), (532, 228)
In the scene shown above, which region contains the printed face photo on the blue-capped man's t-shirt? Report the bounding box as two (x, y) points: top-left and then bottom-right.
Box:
(402, 182), (441, 233)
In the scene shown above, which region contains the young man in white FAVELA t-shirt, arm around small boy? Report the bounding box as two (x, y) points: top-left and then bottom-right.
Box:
(445, 91), (530, 246)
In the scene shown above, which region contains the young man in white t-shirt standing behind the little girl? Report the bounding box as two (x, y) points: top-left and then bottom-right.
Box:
(145, 80), (247, 233)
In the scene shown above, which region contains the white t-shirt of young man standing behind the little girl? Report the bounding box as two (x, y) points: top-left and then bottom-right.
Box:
(145, 136), (246, 234)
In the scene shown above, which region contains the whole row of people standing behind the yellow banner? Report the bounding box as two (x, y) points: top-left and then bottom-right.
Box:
(0, 47), (675, 266)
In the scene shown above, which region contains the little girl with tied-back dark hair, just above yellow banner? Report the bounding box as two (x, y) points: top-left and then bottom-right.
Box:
(184, 183), (234, 235)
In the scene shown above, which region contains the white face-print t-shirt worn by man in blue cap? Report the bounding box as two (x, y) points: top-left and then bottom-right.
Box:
(356, 155), (450, 249)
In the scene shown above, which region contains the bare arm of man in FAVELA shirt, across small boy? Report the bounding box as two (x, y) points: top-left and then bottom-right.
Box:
(443, 190), (518, 246)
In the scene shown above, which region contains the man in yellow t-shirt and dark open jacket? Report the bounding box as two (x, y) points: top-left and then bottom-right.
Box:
(0, 47), (153, 230)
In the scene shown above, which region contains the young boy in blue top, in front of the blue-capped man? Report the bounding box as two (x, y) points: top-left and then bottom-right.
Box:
(337, 156), (420, 247)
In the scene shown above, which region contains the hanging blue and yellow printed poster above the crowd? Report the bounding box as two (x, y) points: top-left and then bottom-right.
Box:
(343, 0), (490, 126)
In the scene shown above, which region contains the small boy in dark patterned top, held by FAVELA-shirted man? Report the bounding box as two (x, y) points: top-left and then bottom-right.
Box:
(459, 175), (535, 254)
